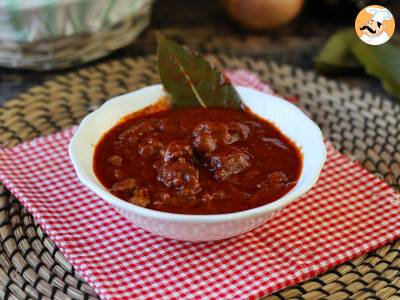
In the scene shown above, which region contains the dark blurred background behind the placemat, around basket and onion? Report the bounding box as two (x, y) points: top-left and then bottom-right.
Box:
(0, 0), (400, 103)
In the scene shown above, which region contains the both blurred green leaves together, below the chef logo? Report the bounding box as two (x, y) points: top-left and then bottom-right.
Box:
(315, 28), (400, 99)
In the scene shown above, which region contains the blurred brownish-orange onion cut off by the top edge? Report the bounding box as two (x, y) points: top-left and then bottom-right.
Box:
(222, 0), (304, 30)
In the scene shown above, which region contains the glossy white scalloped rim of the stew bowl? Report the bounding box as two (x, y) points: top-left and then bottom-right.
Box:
(68, 84), (326, 224)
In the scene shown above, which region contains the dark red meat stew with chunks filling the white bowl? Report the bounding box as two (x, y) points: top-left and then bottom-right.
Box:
(93, 108), (302, 214)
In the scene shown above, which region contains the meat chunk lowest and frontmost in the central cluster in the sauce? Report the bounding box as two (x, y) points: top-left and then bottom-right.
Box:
(157, 159), (201, 195)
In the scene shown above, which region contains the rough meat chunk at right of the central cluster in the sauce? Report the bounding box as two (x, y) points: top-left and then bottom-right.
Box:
(208, 145), (250, 180)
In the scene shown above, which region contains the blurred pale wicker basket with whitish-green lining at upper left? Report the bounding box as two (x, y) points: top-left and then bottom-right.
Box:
(0, 0), (153, 70)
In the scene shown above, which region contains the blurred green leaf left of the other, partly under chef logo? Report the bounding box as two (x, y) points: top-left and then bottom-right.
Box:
(315, 28), (361, 74)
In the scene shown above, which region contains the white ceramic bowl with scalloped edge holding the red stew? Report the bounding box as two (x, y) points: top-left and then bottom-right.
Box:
(69, 85), (326, 241)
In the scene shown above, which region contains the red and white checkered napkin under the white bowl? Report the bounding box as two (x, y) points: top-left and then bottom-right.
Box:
(0, 71), (400, 299)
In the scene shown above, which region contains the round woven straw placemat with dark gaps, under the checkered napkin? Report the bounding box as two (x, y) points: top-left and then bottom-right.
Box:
(0, 56), (400, 299)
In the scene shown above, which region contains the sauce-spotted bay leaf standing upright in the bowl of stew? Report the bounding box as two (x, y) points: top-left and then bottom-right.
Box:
(157, 33), (241, 109)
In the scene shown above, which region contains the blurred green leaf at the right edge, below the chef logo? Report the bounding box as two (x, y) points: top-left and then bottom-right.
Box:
(351, 41), (400, 97)
